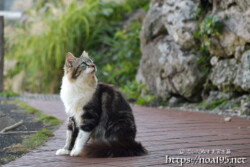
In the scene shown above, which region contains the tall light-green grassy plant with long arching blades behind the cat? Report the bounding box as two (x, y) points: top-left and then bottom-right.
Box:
(6, 0), (149, 93)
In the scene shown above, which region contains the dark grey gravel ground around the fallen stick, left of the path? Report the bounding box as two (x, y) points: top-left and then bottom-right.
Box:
(0, 100), (44, 165)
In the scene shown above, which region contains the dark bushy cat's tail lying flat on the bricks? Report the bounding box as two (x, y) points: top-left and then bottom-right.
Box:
(83, 140), (147, 158)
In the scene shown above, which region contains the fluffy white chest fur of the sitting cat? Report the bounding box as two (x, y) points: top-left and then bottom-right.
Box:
(60, 76), (95, 125)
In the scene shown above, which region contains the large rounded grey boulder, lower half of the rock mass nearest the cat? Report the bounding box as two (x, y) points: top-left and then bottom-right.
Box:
(137, 36), (202, 99)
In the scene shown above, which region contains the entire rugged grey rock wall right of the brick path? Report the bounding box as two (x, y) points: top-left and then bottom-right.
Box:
(136, 0), (250, 101)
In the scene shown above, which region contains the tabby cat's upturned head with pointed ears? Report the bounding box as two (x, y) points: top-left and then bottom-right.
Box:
(64, 51), (97, 81)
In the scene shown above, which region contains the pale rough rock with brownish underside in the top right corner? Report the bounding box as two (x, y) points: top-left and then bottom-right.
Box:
(210, 0), (250, 57)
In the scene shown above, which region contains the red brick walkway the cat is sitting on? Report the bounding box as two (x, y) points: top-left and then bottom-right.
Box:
(4, 100), (250, 167)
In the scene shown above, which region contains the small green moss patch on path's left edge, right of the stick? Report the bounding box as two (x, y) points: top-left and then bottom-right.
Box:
(22, 129), (54, 149)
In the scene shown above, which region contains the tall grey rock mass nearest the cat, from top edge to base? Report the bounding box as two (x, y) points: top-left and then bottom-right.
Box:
(137, 0), (203, 100)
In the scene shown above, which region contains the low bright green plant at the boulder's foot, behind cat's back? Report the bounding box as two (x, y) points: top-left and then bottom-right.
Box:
(120, 81), (155, 105)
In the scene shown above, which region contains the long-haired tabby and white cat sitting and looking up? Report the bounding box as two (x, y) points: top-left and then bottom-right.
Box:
(56, 51), (147, 157)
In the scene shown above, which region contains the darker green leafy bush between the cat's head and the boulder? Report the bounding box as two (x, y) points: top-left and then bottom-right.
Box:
(102, 22), (141, 86)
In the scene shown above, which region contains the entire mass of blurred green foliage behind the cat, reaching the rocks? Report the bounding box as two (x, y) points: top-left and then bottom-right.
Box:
(6, 0), (153, 104)
